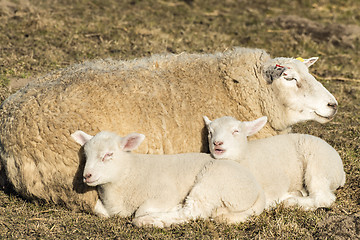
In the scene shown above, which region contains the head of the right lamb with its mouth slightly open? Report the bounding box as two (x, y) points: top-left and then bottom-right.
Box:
(204, 116), (267, 159)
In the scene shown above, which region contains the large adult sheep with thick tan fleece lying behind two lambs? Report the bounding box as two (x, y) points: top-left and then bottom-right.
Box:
(0, 48), (337, 210)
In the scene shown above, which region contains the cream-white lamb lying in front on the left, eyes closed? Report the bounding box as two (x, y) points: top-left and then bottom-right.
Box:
(71, 130), (265, 227)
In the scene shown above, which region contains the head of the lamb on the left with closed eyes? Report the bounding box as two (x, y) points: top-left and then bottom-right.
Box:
(71, 130), (145, 186)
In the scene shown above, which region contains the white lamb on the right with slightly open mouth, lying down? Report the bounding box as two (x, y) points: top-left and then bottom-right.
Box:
(204, 116), (345, 210)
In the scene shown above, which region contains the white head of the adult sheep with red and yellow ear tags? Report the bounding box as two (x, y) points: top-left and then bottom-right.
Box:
(264, 58), (338, 126)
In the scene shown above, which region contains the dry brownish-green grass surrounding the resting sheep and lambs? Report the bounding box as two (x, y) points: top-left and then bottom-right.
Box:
(0, 0), (360, 239)
